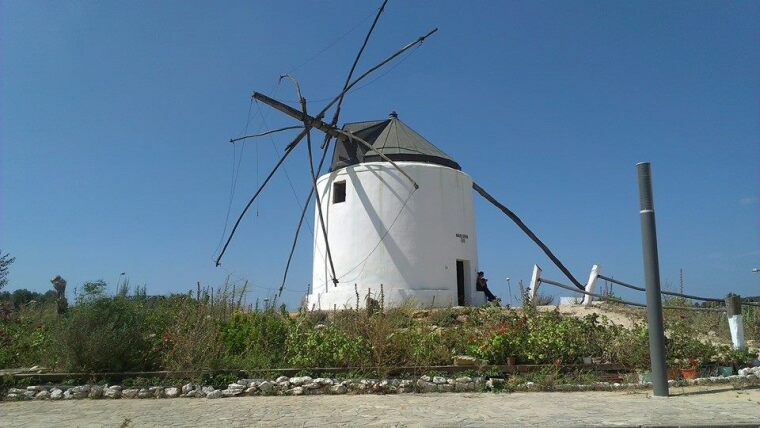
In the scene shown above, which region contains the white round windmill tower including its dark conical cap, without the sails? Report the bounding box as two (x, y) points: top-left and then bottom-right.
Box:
(307, 114), (485, 309)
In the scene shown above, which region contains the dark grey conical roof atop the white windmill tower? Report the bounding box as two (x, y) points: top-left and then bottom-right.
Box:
(330, 112), (462, 171)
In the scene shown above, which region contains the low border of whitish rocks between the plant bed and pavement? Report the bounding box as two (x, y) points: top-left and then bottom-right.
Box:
(3, 367), (760, 401)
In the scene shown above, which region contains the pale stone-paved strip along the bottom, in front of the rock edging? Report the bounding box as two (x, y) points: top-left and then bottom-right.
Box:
(0, 388), (760, 427)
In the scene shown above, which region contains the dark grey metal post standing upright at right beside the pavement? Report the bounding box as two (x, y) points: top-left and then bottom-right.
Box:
(636, 162), (668, 397)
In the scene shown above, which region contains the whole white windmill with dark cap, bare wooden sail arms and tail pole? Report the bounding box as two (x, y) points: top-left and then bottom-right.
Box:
(216, 0), (583, 308)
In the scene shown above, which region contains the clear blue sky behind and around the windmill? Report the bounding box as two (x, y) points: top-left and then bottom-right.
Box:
(0, 0), (760, 303)
